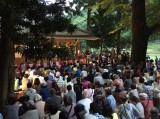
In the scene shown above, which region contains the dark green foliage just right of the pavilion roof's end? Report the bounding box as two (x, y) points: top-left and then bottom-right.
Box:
(90, 8), (115, 48)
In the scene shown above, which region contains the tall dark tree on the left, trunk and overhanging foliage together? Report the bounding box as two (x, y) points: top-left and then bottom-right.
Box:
(0, 0), (74, 112)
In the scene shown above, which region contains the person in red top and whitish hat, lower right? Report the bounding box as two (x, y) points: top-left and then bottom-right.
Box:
(139, 93), (153, 119)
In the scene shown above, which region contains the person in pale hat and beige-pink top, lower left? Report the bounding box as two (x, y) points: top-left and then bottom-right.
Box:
(33, 94), (45, 119)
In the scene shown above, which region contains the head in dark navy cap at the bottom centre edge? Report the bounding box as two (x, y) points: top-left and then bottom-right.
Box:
(74, 104), (87, 119)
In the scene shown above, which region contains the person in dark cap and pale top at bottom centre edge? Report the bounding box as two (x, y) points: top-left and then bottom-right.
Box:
(74, 104), (97, 119)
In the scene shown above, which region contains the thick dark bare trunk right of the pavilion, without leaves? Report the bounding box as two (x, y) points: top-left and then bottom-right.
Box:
(131, 0), (149, 65)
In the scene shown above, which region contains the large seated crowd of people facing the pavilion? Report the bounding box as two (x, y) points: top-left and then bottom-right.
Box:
(0, 52), (160, 119)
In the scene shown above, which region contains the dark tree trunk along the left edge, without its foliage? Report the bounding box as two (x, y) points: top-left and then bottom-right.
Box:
(0, 12), (15, 112)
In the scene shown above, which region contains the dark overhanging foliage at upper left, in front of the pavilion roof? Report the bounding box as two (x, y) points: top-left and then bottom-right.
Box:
(0, 0), (76, 61)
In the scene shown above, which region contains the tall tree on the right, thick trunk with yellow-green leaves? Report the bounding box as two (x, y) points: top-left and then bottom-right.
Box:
(97, 0), (160, 65)
